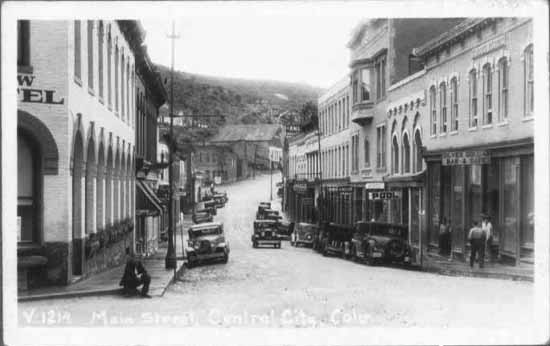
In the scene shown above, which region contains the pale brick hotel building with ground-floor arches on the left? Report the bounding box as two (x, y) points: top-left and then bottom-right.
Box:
(17, 20), (141, 288)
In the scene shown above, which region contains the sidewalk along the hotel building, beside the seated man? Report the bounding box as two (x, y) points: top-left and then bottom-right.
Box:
(18, 216), (195, 302)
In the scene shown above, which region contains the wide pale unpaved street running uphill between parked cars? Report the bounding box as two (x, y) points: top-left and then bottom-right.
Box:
(19, 175), (533, 328)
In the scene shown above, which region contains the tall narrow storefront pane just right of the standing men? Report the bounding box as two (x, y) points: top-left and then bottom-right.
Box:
(502, 157), (519, 254)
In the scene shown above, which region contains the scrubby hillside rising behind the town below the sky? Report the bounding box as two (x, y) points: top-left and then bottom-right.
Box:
(157, 65), (322, 124)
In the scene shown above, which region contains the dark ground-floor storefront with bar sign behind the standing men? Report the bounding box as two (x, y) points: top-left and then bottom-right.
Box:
(425, 139), (534, 264)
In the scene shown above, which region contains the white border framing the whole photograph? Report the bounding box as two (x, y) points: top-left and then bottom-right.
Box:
(1, 0), (550, 345)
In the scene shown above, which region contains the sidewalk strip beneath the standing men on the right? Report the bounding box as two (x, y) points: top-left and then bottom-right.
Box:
(422, 252), (534, 282)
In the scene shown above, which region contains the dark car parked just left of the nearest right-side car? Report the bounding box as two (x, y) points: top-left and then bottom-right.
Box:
(319, 222), (354, 258)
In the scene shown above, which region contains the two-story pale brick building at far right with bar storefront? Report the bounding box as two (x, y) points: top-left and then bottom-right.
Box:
(415, 18), (535, 263)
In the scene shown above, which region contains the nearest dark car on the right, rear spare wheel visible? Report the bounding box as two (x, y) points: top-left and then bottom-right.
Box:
(352, 222), (412, 265)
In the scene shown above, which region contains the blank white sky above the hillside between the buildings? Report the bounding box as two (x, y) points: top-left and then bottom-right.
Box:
(142, 2), (364, 88)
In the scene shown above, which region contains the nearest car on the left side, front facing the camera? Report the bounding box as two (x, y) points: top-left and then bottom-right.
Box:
(186, 222), (229, 267)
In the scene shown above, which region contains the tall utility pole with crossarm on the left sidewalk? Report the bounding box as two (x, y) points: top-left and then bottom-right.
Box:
(164, 21), (180, 270)
